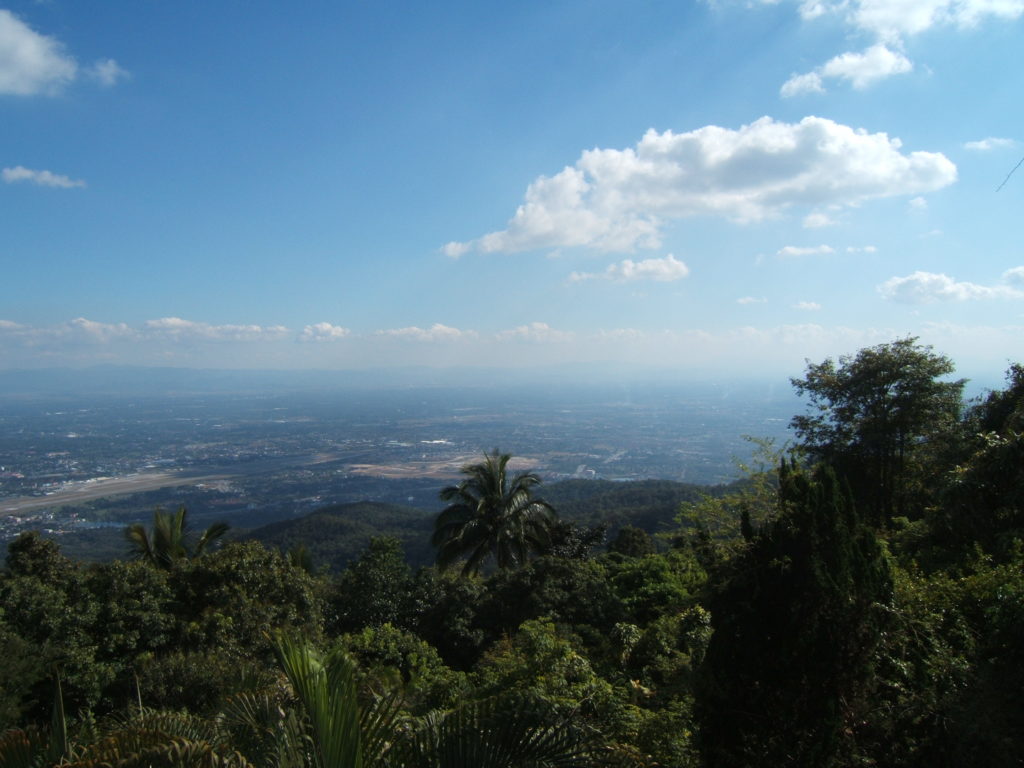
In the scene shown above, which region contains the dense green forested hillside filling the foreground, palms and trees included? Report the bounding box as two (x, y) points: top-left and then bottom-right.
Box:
(0, 339), (1024, 768)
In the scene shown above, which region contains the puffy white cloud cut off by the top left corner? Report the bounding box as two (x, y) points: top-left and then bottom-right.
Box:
(0, 9), (78, 96)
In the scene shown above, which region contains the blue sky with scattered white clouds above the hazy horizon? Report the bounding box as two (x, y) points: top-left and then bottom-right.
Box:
(0, 0), (1024, 377)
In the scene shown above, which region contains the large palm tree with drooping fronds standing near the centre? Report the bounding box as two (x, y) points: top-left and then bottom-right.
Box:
(430, 449), (556, 575)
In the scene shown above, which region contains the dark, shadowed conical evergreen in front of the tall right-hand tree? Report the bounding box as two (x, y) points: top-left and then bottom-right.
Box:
(697, 465), (892, 766)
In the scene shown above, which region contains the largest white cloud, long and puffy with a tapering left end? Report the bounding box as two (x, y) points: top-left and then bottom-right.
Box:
(444, 117), (956, 255)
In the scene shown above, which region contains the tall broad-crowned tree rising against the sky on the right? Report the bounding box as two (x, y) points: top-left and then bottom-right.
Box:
(791, 337), (965, 523)
